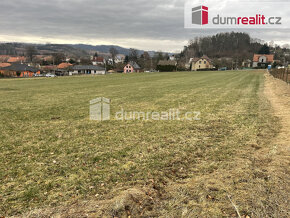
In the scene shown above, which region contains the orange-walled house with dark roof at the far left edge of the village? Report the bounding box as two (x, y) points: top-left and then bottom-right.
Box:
(0, 63), (40, 78)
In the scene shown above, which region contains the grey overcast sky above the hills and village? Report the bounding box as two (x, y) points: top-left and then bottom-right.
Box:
(0, 0), (290, 51)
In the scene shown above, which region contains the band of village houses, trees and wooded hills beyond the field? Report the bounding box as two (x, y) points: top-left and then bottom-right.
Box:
(0, 32), (290, 77)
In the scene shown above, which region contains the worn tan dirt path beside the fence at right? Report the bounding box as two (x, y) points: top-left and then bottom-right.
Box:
(256, 73), (290, 217)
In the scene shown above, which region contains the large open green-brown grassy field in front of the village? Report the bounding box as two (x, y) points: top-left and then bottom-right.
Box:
(0, 71), (279, 217)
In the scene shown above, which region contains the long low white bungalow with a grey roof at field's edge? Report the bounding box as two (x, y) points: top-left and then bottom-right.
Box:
(69, 65), (106, 76)
